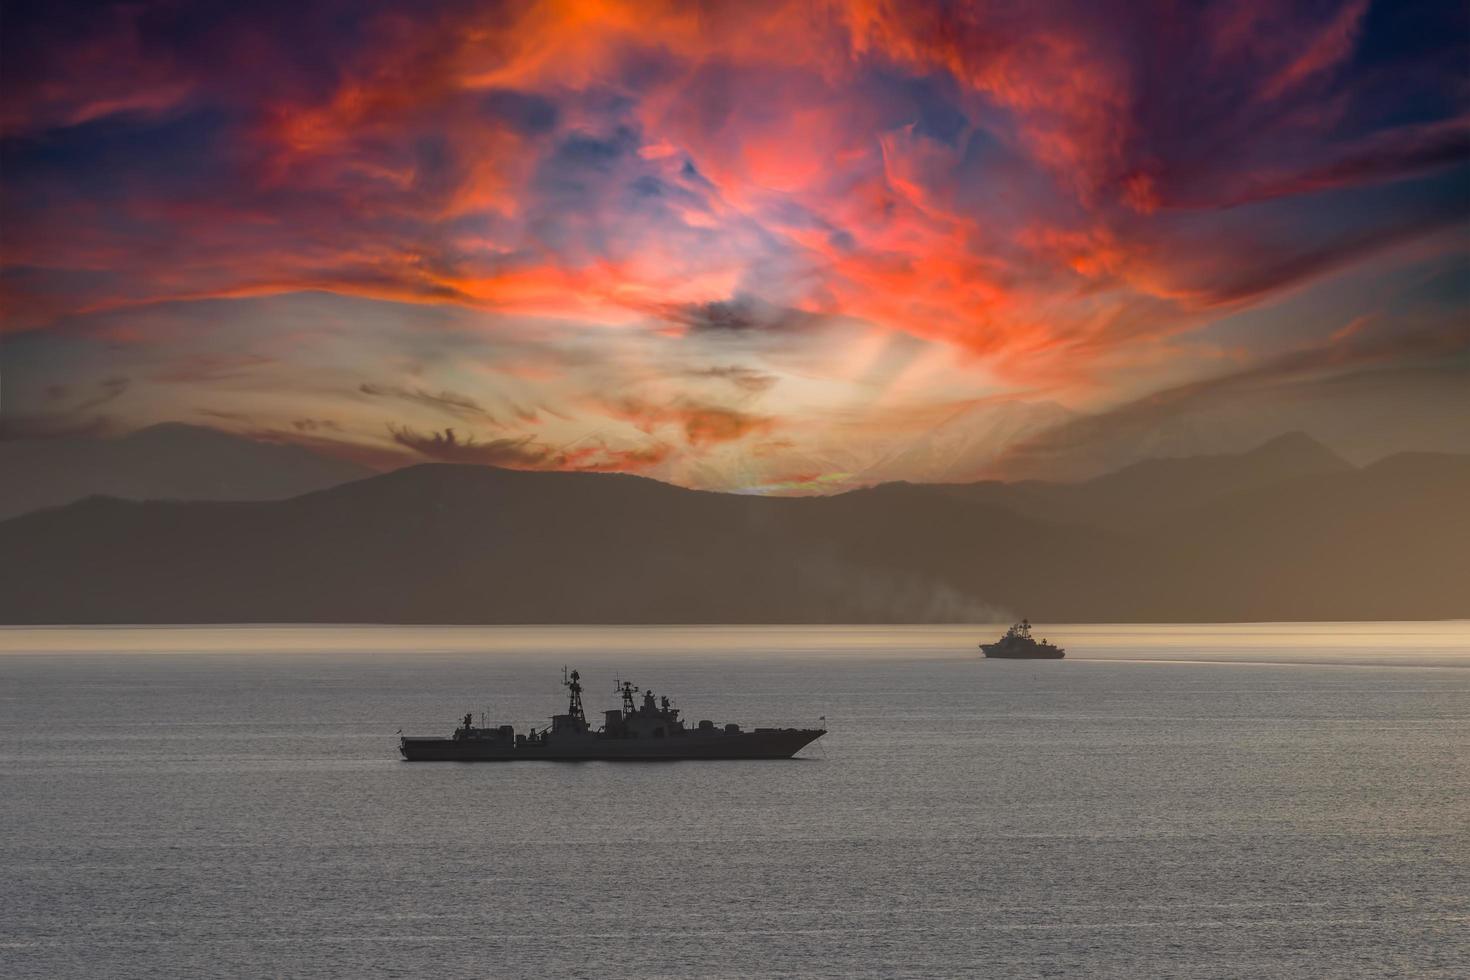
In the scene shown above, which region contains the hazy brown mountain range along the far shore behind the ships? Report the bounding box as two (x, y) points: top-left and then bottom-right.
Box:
(0, 435), (1470, 623)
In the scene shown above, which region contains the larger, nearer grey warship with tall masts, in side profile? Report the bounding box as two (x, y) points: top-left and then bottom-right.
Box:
(398, 669), (826, 763)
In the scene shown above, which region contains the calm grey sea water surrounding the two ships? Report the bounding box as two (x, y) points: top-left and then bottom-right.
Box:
(0, 623), (1470, 977)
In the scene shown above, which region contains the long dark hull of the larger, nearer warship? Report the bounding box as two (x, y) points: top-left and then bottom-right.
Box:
(398, 729), (826, 763)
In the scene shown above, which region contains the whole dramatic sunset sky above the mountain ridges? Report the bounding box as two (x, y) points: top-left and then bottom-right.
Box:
(0, 0), (1470, 492)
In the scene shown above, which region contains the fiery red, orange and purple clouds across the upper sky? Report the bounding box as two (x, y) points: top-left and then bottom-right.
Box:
(0, 0), (1466, 481)
